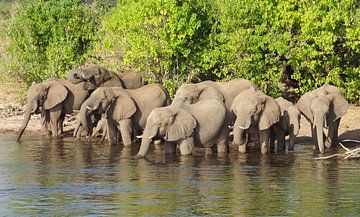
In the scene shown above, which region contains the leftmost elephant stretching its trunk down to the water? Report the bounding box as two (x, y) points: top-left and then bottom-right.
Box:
(17, 79), (89, 140)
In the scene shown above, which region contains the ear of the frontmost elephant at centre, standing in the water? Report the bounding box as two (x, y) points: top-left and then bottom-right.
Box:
(165, 109), (197, 142)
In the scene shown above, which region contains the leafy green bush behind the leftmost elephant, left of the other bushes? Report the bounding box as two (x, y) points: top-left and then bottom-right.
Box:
(8, 0), (99, 83)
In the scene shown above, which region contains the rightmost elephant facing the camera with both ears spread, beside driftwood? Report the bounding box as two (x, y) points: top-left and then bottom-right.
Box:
(296, 84), (349, 153)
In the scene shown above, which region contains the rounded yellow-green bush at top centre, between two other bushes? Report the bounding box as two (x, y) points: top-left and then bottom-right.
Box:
(95, 0), (217, 94)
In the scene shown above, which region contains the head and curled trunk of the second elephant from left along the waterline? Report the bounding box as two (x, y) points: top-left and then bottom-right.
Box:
(80, 87), (137, 135)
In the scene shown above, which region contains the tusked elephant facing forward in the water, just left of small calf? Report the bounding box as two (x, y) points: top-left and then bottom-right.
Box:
(231, 89), (281, 154)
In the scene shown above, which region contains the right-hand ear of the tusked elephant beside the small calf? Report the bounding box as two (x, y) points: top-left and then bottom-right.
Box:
(259, 95), (281, 130)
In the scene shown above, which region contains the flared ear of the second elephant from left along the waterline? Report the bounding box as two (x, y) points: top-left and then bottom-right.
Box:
(106, 90), (136, 120)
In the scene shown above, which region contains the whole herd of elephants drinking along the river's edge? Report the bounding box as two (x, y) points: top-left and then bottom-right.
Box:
(17, 65), (348, 157)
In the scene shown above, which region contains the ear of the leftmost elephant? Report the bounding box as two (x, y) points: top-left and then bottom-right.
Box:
(44, 81), (68, 110)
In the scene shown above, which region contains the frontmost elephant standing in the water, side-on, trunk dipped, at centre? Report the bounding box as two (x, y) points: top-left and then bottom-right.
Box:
(137, 99), (228, 157)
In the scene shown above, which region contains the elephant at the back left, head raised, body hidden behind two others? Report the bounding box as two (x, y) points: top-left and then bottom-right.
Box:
(67, 65), (144, 90)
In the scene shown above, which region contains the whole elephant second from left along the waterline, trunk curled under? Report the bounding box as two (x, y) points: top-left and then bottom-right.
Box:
(80, 84), (170, 146)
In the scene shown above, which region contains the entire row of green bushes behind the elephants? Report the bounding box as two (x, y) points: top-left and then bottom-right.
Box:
(0, 0), (360, 103)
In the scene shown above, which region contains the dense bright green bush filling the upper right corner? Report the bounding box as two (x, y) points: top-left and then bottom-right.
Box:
(205, 0), (360, 102)
